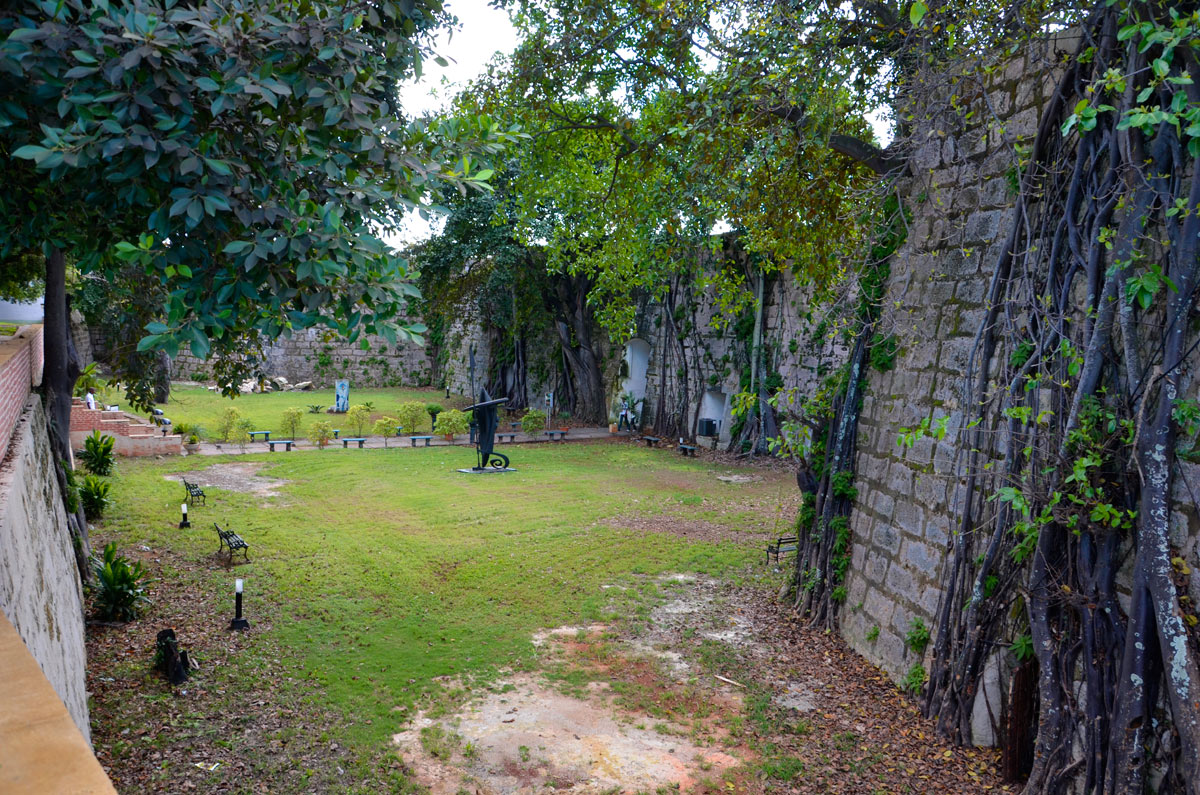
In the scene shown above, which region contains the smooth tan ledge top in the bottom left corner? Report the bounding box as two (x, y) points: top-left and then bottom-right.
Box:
(0, 612), (116, 795)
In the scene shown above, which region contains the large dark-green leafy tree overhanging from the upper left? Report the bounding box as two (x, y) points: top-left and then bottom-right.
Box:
(0, 0), (508, 572)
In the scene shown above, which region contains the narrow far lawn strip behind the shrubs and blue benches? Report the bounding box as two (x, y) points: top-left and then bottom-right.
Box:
(150, 384), (470, 438)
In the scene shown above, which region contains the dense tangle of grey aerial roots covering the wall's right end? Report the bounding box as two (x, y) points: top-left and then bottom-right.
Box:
(902, 0), (1200, 793)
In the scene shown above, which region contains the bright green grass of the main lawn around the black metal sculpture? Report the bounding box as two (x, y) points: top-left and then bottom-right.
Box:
(92, 444), (794, 787)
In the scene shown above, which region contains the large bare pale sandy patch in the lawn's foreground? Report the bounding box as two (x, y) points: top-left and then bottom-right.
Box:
(394, 677), (739, 795)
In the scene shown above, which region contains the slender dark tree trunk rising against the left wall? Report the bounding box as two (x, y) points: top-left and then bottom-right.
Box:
(42, 249), (91, 582)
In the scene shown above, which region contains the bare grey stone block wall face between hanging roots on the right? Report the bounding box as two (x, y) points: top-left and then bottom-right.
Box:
(841, 44), (1075, 686)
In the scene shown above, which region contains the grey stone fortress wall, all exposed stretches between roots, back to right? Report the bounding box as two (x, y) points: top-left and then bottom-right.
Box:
(162, 29), (1200, 740)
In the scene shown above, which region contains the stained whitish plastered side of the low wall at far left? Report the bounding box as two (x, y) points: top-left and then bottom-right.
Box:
(0, 395), (91, 737)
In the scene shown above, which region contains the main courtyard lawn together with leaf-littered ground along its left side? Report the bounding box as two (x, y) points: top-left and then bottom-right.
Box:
(90, 439), (794, 791)
